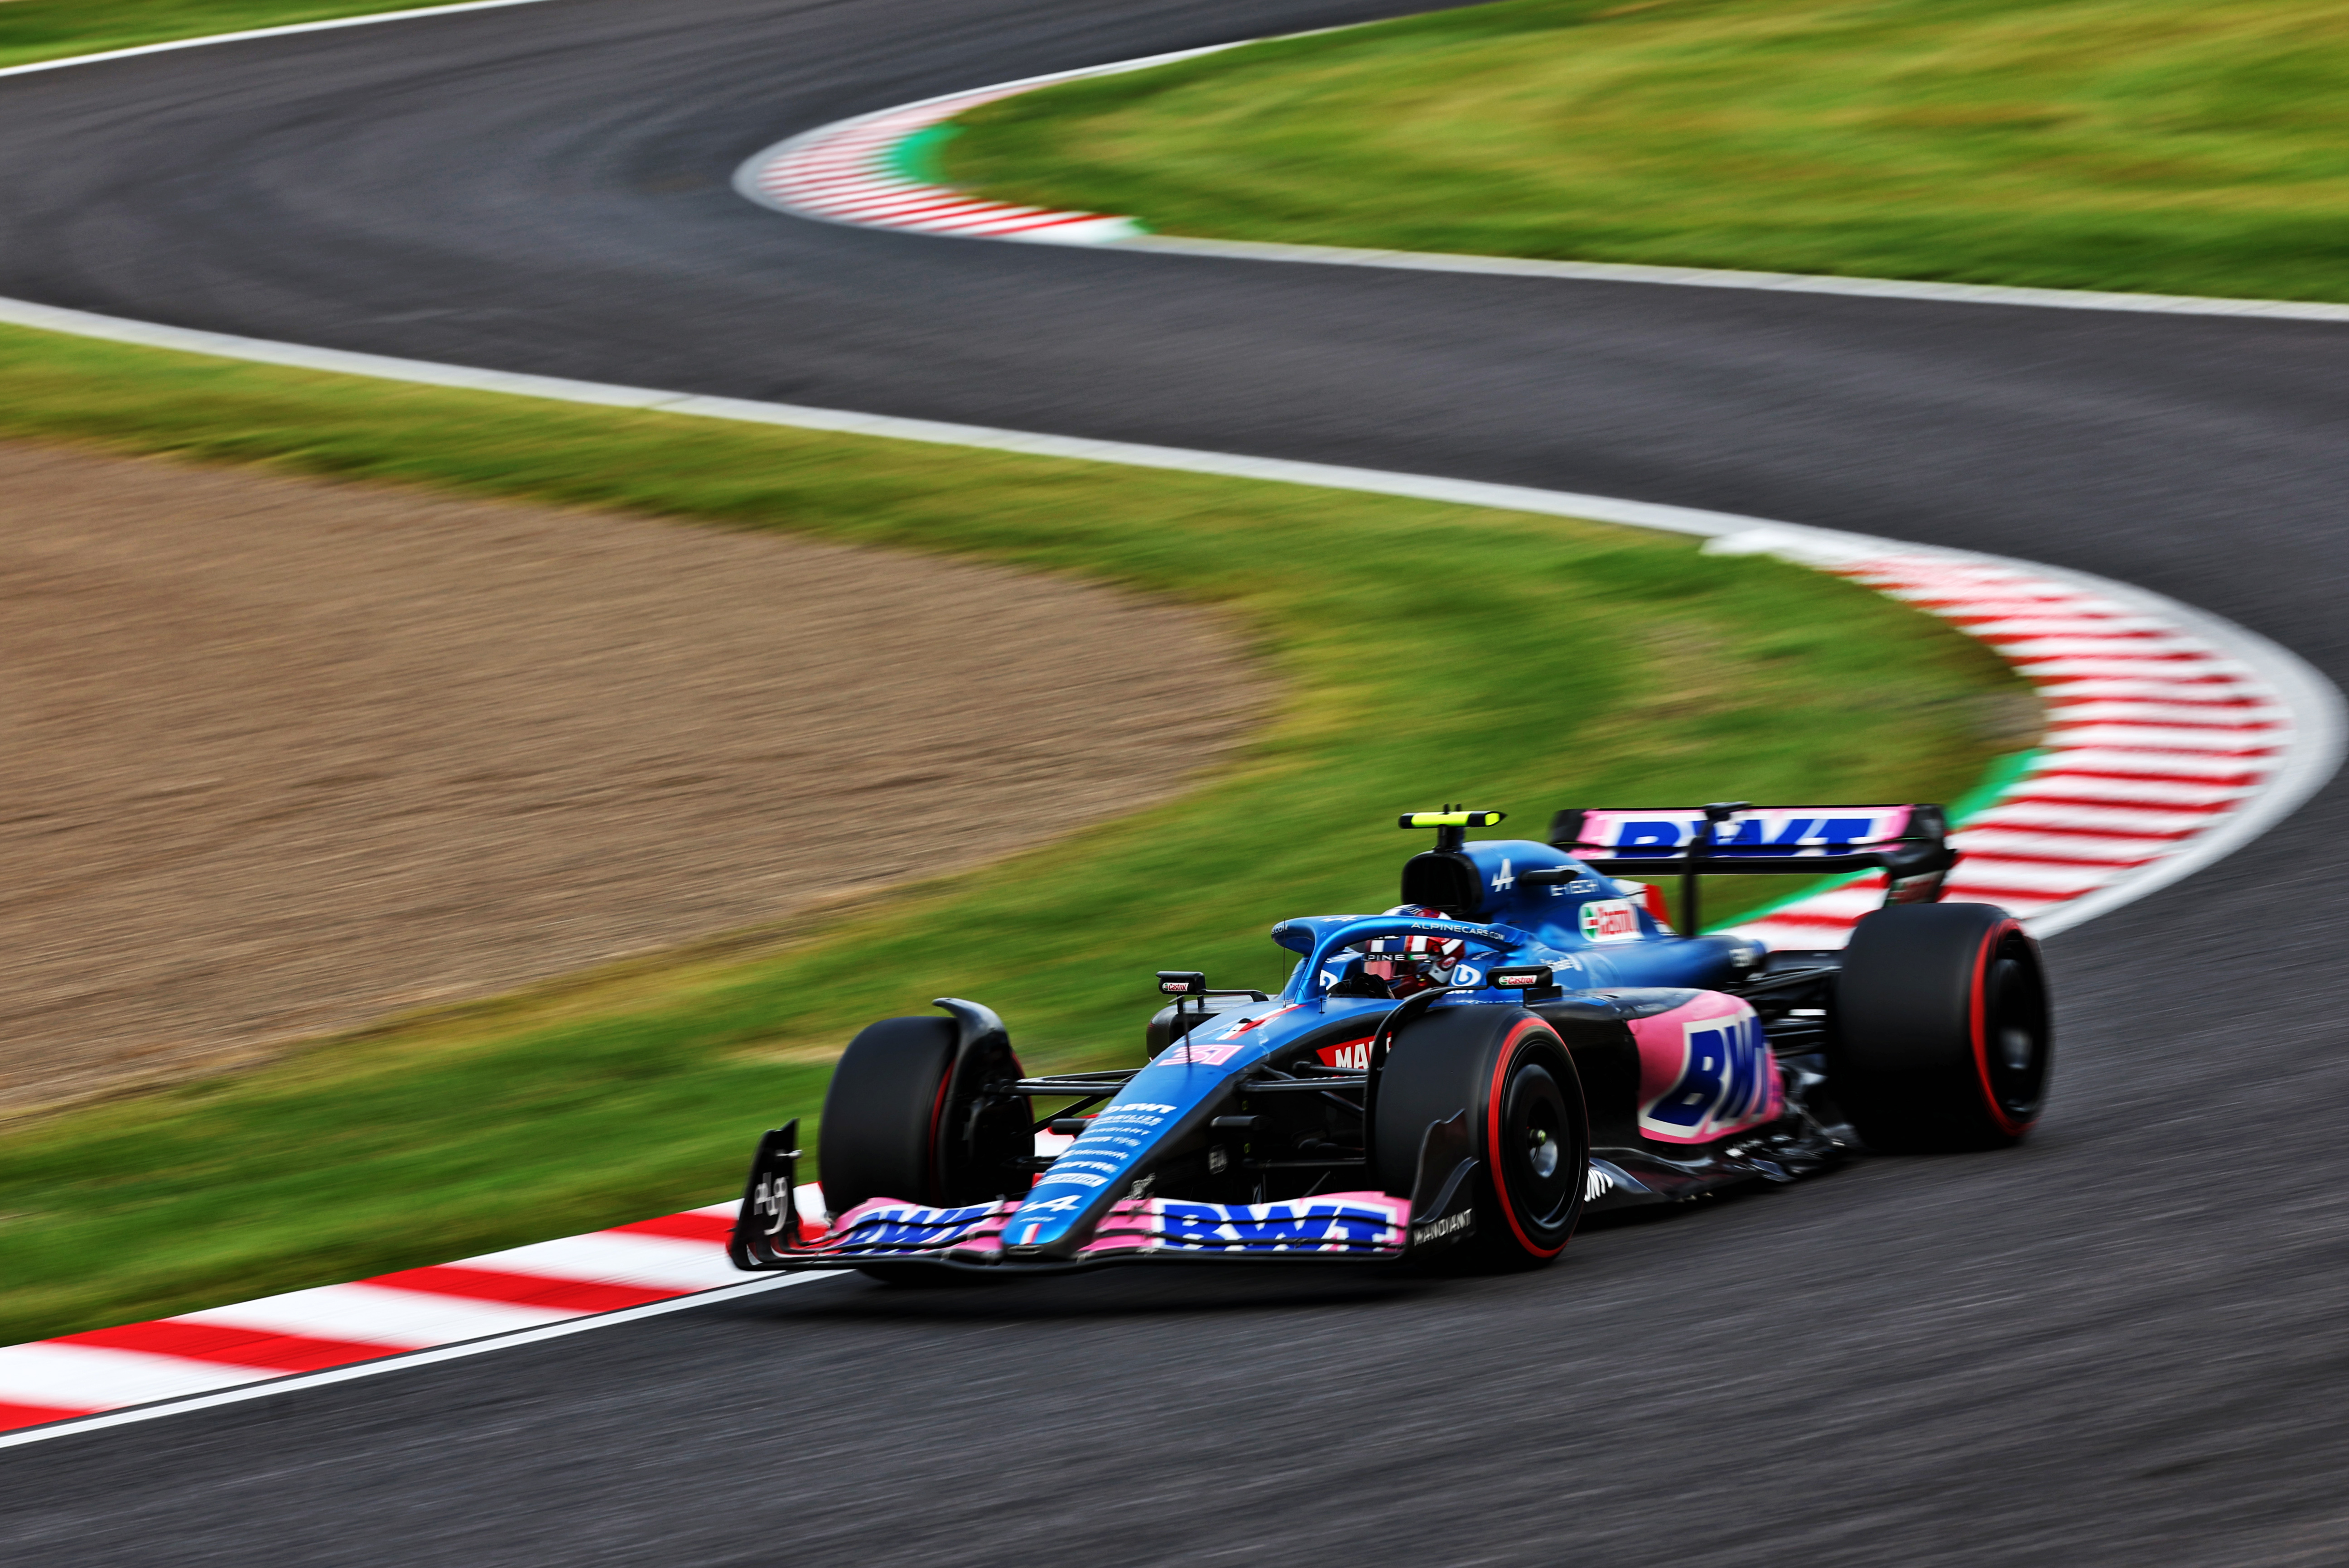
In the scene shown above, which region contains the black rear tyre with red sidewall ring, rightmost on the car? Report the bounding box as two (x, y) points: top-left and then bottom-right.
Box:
(1832, 904), (2055, 1153)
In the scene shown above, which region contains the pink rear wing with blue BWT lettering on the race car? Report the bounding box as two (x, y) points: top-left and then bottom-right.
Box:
(1550, 801), (1957, 936)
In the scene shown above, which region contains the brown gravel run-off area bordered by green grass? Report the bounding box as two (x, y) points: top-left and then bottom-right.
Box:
(0, 444), (1271, 1113)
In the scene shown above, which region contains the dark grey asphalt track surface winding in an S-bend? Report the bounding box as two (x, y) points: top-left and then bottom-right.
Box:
(0, 0), (2349, 1568)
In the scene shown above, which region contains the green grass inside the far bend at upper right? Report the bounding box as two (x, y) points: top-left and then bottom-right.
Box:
(932, 0), (2349, 300)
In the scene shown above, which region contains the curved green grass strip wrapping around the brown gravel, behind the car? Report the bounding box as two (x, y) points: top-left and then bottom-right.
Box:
(0, 331), (2020, 1343)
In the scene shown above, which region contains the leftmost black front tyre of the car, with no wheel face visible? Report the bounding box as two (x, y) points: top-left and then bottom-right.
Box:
(817, 1019), (1036, 1284)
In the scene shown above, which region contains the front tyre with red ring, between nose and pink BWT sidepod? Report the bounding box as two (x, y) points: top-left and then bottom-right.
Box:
(1372, 1007), (1590, 1268)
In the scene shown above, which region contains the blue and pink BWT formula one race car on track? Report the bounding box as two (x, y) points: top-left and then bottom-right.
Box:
(731, 803), (2051, 1282)
